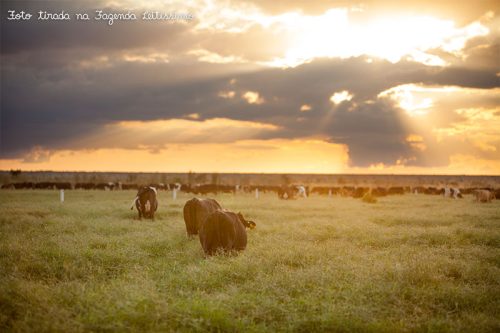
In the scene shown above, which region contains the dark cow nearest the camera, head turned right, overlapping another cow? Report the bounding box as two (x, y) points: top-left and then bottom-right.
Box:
(200, 210), (256, 255)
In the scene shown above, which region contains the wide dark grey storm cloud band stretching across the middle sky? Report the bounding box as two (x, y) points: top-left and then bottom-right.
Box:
(2, 51), (499, 166)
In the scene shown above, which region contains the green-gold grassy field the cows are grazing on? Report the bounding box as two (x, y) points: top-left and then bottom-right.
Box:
(0, 191), (500, 332)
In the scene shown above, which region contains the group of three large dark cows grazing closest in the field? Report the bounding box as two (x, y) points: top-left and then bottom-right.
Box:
(131, 186), (256, 255)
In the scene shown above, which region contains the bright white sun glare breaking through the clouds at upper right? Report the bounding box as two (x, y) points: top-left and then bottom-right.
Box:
(271, 9), (489, 67)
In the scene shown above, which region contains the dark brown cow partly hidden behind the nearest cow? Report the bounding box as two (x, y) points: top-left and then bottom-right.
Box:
(184, 198), (222, 237)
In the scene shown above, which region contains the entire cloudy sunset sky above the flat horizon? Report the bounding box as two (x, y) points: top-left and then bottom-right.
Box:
(0, 0), (500, 175)
